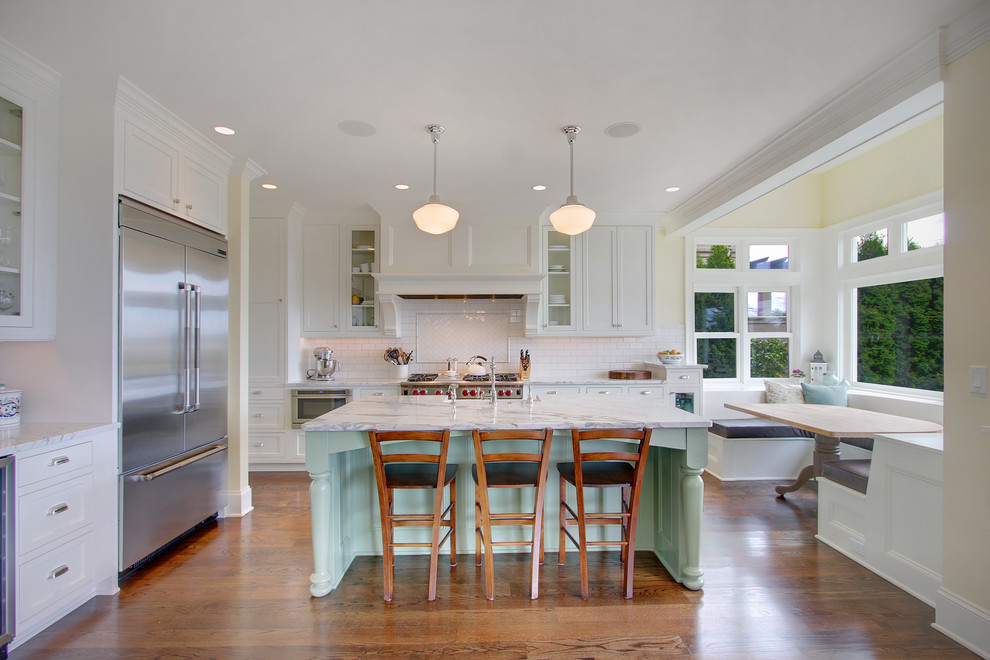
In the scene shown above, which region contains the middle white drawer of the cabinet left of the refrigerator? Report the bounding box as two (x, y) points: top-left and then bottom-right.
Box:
(17, 474), (93, 555)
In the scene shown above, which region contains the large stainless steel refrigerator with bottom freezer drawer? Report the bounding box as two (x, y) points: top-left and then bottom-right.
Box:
(118, 198), (228, 571)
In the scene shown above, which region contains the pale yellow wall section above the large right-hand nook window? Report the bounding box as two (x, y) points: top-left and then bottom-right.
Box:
(822, 117), (942, 225)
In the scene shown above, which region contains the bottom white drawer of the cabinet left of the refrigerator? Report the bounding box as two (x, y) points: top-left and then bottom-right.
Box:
(17, 533), (93, 628)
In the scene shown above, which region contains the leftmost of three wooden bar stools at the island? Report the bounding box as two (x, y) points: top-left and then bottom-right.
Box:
(368, 430), (458, 601)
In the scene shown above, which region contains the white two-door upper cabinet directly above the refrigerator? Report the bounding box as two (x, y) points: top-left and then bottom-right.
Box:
(119, 86), (231, 235)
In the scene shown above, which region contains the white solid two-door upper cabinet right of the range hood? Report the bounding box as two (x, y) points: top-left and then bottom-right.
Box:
(581, 226), (654, 335)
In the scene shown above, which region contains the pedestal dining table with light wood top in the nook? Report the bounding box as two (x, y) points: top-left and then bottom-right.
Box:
(724, 403), (942, 497)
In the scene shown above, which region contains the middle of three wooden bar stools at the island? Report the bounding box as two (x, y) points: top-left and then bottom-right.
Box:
(471, 429), (553, 600)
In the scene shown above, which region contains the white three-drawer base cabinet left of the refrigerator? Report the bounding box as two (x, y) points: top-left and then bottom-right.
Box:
(11, 430), (117, 648)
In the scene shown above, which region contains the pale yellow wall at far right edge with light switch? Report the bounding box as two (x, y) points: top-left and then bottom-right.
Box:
(942, 42), (990, 610)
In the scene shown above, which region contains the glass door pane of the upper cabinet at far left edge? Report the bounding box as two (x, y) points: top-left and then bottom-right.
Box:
(0, 97), (24, 316)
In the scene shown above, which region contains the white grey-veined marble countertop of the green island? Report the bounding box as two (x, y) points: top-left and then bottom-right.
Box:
(302, 394), (711, 432)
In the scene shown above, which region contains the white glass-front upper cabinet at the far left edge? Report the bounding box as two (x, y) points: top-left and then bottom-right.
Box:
(0, 44), (59, 341)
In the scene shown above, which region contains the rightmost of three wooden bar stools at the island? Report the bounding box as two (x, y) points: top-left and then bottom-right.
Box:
(557, 428), (651, 600)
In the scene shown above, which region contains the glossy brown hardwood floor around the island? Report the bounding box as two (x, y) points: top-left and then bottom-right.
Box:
(11, 472), (977, 660)
